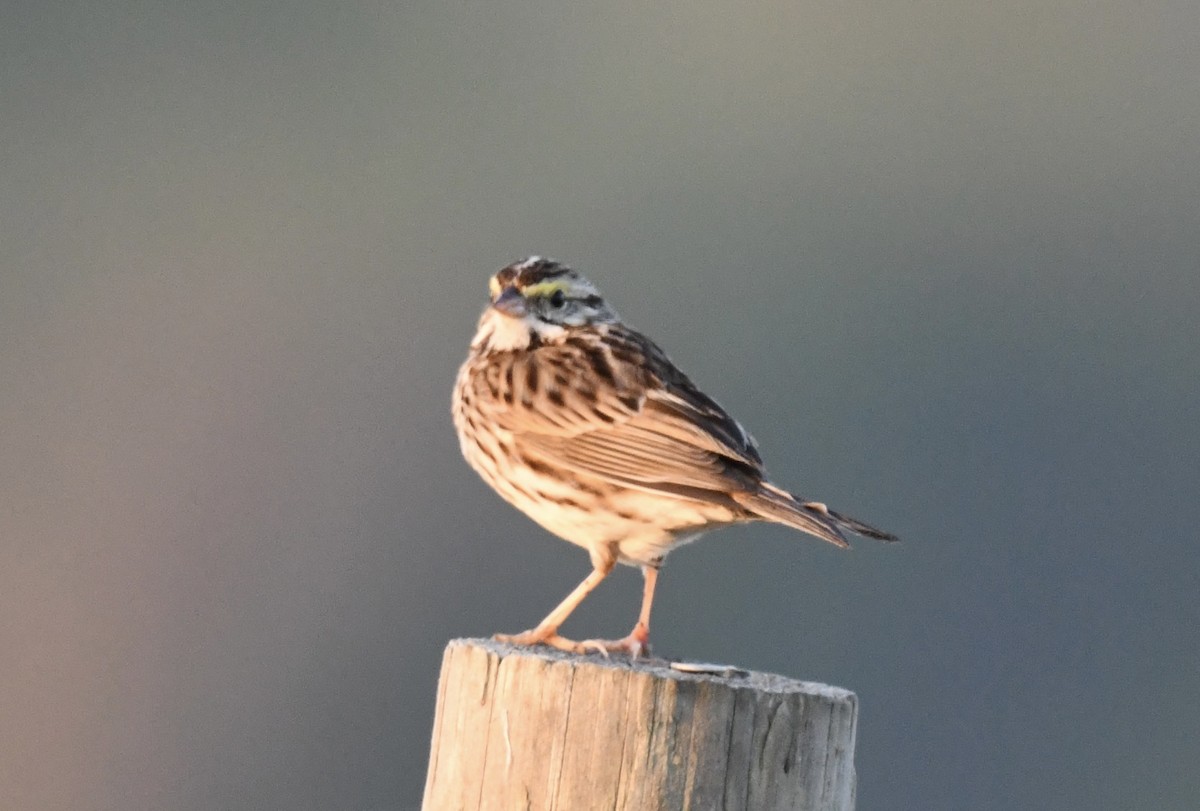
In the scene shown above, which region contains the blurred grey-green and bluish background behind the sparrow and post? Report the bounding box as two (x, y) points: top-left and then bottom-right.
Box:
(0, 0), (1200, 811)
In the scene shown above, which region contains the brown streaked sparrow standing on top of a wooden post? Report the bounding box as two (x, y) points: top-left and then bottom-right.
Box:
(451, 256), (896, 659)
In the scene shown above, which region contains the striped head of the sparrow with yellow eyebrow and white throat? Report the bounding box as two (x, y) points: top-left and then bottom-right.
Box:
(473, 257), (618, 350)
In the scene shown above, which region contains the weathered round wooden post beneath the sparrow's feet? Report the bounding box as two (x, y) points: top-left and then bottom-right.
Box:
(424, 639), (858, 811)
